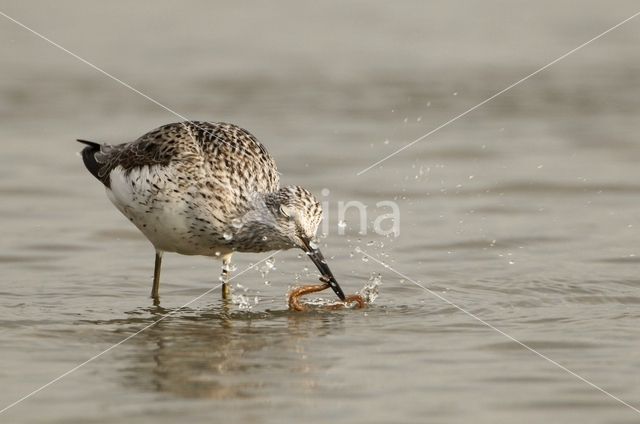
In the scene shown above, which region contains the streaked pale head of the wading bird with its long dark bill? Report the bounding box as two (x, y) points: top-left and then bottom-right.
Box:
(267, 186), (345, 301)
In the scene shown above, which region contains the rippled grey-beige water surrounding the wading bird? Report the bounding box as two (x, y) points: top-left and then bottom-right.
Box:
(0, 0), (640, 423)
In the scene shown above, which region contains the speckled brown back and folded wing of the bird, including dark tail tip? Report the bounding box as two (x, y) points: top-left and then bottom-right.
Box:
(76, 121), (279, 192)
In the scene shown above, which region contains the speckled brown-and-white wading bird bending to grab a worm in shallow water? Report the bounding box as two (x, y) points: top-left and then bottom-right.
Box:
(78, 121), (345, 302)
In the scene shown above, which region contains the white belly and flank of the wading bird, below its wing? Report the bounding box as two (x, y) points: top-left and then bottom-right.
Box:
(107, 166), (230, 256)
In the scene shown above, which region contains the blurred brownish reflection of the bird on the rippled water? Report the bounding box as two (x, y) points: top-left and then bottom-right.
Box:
(92, 305), (343, 399)
